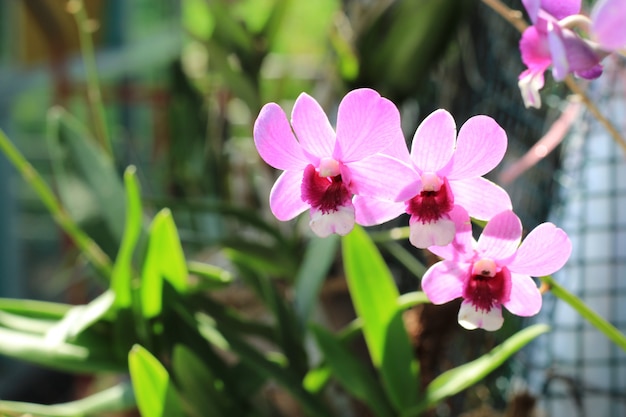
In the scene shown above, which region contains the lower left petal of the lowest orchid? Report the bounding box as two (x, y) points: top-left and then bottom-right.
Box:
(422, 261), (469, 304)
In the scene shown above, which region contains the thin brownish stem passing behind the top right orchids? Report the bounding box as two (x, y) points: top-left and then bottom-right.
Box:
(482, 0), (626, 152)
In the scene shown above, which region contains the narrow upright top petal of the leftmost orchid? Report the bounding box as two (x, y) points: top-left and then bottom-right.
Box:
(291, 93), (335, 160)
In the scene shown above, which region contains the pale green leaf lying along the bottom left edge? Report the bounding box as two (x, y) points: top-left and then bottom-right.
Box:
(0, 383), (136, 417)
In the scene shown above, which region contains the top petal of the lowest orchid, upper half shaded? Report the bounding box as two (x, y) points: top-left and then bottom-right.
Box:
(476, 210), (522, 261)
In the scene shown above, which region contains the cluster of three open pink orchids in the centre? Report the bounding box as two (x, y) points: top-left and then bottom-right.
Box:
(254, 89), (571, 330)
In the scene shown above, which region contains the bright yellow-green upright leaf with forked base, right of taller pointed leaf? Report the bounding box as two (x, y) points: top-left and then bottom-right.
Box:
(140, 209), (188, 318)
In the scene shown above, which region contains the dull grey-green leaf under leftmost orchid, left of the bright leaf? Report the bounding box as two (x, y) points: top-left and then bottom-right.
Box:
(295, 235), (339, 329)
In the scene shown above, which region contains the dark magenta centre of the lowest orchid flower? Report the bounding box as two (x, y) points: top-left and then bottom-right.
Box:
(463, 258), (511, 312)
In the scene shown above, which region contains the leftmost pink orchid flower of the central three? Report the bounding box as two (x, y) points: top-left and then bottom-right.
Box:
(254, 89), (410, 237)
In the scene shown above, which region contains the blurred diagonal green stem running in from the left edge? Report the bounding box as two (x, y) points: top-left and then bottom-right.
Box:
(0, 129), (112, 277)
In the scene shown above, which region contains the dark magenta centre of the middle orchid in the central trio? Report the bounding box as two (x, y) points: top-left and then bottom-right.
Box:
(406, 173), (454, 223)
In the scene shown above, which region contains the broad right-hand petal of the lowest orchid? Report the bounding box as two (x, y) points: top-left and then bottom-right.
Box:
(508, 223), (572, 277)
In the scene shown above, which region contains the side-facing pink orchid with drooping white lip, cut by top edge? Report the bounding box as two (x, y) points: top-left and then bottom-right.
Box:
(518, 0), (607, 108)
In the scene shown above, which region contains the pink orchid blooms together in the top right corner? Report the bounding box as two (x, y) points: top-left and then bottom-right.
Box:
(519, 0), (626, 108)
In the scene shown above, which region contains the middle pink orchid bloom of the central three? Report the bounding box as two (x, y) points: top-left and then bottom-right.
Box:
(354, 109), (511, 248)
